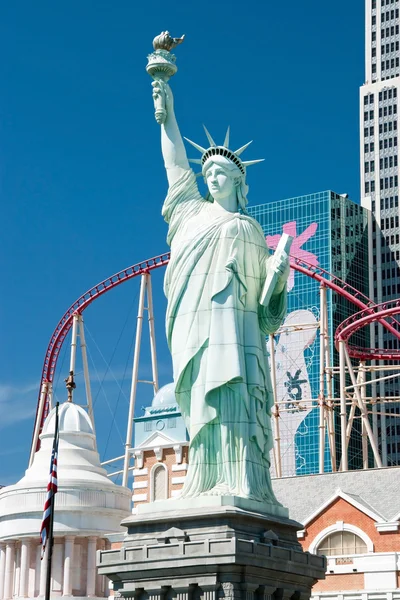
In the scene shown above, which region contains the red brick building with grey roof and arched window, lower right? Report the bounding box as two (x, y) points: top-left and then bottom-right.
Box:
(273, 467), (400, 600)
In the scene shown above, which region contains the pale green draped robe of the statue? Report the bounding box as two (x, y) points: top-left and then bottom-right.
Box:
(163, 170), (286, 503)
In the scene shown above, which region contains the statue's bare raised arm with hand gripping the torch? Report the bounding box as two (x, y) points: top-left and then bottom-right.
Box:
(152, 80), (190, 186)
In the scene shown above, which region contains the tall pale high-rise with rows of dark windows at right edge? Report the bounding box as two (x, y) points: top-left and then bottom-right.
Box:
(360, 0), (400, 465)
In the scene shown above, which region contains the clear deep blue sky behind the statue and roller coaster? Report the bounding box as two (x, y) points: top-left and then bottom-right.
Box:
(0, 0), (364, 484)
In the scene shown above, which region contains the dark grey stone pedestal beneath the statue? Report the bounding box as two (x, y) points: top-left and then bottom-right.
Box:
(97, 498), (326, 600)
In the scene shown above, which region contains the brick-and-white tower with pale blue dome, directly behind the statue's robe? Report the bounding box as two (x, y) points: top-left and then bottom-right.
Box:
(133, 383), (189, 511)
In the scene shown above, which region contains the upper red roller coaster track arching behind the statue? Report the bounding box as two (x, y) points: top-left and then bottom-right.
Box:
(31, 253), (400, 450)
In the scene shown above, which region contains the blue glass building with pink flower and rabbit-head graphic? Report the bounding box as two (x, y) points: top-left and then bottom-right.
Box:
(248, 191), (368, 476)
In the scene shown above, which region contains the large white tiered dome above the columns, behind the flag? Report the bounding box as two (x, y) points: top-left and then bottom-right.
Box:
(0, 402), (131, 540)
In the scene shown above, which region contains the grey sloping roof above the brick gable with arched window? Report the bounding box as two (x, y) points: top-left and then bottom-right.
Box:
(272, 467), (400, 523)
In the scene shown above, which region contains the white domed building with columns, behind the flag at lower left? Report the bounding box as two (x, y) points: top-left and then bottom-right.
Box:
(0, 402), (131, 600)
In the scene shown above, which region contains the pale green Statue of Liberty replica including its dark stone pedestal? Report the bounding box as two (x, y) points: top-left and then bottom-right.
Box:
(98, 32), (326, 600)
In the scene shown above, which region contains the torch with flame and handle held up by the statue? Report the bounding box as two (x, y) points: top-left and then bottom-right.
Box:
(146, 31), (185, 124)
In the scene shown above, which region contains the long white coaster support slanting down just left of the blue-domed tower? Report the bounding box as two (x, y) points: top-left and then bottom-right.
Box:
(122, 273), (147, 487)
